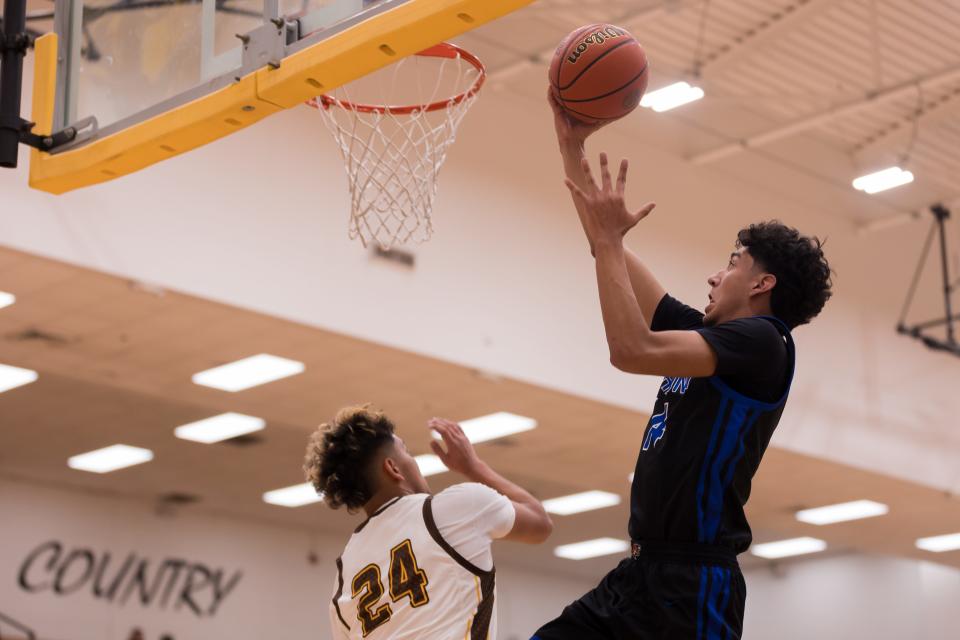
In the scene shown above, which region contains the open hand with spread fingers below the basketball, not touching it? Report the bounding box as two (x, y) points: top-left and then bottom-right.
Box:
(566, 153), (656, 246)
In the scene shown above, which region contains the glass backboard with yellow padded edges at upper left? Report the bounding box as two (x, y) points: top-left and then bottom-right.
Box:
(30, 0), (532, 193)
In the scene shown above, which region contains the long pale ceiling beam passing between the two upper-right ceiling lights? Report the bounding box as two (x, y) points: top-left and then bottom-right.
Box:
(688, 66), (960, 164)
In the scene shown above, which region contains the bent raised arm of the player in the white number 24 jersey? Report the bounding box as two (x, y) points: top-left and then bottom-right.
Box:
(428, 418), (553, 544)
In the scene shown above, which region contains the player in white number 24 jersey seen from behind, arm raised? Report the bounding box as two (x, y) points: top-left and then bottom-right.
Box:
(304, 407), (553, 640)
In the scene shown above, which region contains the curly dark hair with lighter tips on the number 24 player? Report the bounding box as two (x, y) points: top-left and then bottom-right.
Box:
(303, 406), (394, 513)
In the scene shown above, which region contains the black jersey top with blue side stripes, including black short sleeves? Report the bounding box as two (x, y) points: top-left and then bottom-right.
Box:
(629, 295), (794, 553)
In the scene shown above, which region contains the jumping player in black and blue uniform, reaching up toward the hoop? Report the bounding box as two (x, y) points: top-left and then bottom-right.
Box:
(534, 94), (831, 640)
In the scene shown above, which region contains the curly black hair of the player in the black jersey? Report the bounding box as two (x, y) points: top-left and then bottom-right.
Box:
(737, 220), (833, 329)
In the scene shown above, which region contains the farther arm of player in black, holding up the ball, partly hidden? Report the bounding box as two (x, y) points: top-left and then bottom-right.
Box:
(547, 90), (666, 326)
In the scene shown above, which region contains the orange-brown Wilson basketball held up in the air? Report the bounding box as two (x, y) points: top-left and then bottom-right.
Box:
(550, 23), (649, 123)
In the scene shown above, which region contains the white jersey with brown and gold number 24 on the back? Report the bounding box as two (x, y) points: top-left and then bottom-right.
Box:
(330, 484), (515, 640)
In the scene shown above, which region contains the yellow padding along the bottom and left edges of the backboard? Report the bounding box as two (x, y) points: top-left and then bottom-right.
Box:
(30, 0), (532, 194)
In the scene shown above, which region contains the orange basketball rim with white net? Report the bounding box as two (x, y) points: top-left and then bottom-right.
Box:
(307, 43), (486, 250)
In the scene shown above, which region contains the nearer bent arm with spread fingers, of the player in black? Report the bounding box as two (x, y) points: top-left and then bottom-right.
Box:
(567, 154), (717, 378)
